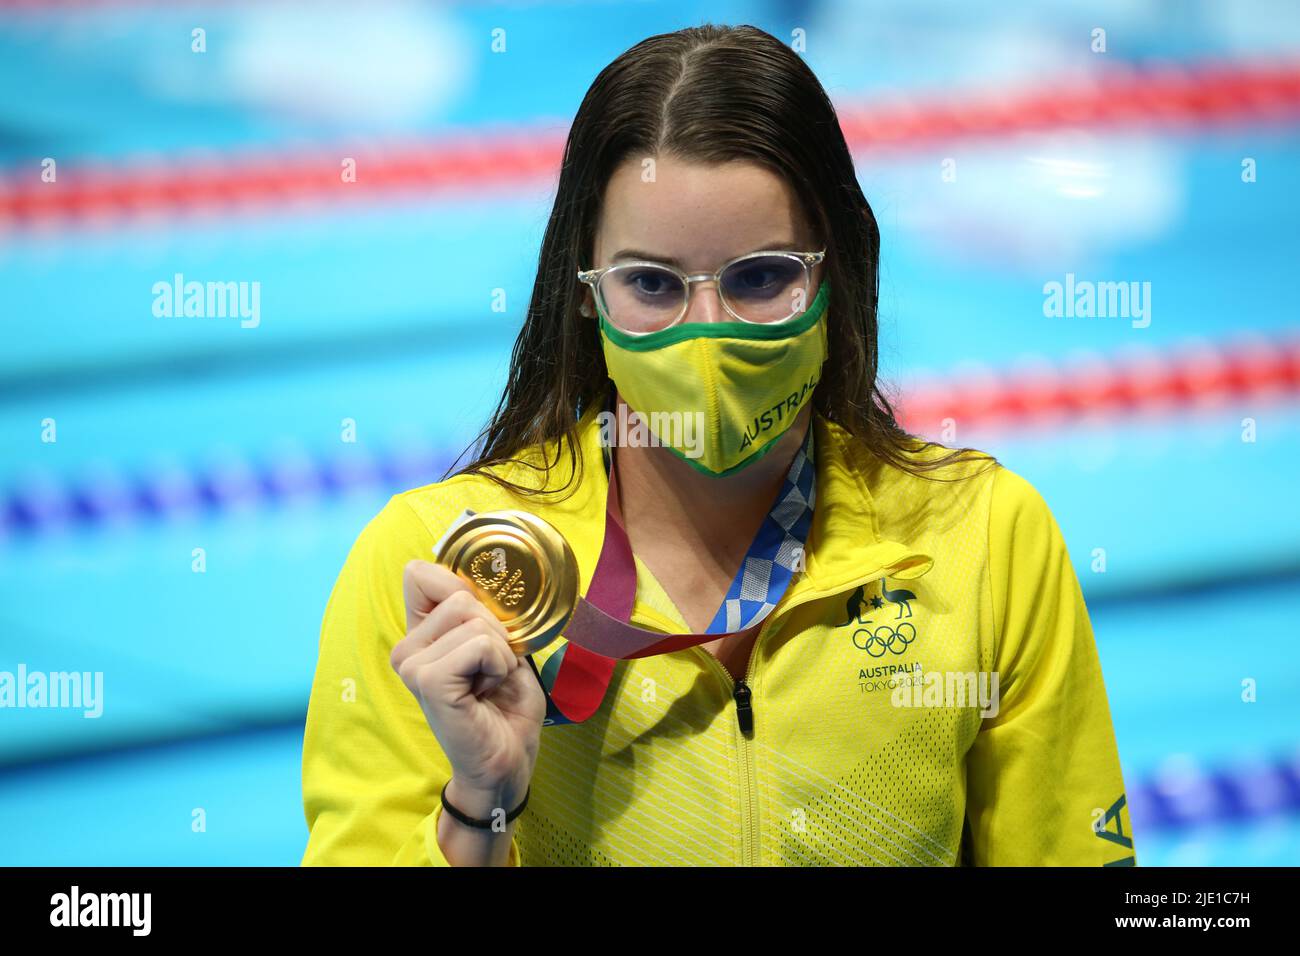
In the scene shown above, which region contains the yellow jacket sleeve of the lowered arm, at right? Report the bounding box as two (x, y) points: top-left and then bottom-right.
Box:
(966, 467), (1136, 866)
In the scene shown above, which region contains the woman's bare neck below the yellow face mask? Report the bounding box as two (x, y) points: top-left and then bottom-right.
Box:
(615, 395), (813, 566)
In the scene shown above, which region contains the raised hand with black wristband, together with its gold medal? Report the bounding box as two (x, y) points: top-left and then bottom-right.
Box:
(390, 512), (561, 865)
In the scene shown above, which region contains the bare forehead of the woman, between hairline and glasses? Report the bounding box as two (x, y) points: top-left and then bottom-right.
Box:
(594, 156), (809, 271)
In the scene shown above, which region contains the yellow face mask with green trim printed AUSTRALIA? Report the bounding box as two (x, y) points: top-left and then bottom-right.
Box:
(598, 280), (829, 477)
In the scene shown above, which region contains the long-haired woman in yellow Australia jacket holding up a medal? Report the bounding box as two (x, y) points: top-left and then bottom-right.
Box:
(303, 26), (1135, 866)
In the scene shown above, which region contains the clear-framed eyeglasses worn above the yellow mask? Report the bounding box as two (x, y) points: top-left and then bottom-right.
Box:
(577, 248), (826, 334)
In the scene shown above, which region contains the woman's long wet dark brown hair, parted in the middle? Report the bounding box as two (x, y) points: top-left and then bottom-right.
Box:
(445, 25), (995, 494)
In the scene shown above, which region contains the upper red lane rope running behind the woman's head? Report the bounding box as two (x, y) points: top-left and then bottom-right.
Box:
(0, 62), (1300, 226)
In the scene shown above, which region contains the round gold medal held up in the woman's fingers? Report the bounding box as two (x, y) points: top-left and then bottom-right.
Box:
(436, 511), (577, 654)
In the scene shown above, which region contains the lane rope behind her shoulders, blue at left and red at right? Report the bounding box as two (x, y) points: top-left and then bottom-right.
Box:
(0, 336), (1300, 541)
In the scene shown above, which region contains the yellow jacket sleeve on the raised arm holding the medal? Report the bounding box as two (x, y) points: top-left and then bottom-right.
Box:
(302, 494), (523, 866)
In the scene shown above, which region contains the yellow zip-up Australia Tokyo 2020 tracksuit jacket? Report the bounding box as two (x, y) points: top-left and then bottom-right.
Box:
(303, 407), (1136, 866)
